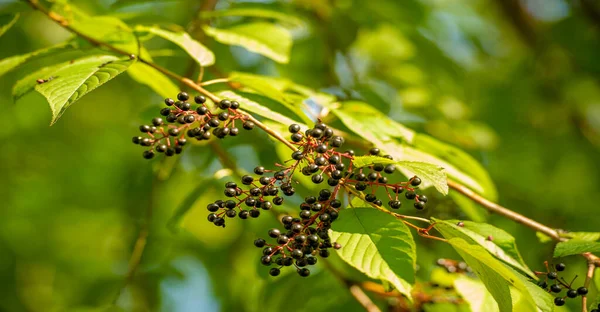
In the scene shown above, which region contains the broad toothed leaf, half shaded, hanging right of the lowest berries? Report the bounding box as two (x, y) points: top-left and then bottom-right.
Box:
(331, 208), (416, 298)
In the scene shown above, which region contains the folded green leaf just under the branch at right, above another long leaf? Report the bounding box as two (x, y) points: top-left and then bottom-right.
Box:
(434, 219), (535, 277)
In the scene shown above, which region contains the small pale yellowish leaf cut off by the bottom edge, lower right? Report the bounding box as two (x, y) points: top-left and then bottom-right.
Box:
(454, 275), (499, 312)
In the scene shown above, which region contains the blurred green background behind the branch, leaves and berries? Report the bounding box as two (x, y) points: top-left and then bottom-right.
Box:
(0, 0), (600, 311)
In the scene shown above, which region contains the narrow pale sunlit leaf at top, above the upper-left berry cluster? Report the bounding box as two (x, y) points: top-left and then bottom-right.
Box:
(136, 26), (215, 67)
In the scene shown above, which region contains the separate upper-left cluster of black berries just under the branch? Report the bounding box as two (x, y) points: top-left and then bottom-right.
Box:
(132, 92), (254, 159)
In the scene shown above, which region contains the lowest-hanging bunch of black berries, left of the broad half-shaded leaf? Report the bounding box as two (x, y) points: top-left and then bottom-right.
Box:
(254, 193), (342, 277)
